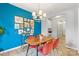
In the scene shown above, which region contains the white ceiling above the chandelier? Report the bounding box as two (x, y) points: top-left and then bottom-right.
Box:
(11, 3), (76, 17)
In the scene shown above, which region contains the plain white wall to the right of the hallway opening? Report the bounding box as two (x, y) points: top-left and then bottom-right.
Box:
(66, 9), (77, 49)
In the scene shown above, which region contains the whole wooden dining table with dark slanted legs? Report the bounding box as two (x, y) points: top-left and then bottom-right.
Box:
(26, 36), (53, 56)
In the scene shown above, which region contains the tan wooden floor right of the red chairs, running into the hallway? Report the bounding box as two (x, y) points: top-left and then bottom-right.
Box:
(59, 35), (79, 56)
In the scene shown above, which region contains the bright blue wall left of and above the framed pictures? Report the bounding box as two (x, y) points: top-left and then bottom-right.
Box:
(0, 3), (32, 50)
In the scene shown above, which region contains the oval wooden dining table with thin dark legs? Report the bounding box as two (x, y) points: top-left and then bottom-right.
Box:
(26, 37), (53, 56)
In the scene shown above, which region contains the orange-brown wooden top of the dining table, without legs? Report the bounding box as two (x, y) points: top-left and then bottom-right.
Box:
(26, 37), (53, 45)
